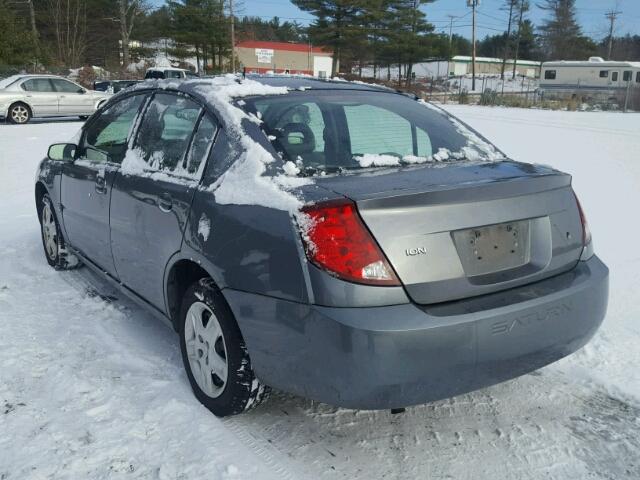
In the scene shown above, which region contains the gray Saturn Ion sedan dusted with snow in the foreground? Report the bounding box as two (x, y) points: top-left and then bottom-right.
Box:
(35, 77), (608, 416)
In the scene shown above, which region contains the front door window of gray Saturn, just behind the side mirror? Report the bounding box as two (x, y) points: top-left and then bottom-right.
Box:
(80, 95), (146, 163)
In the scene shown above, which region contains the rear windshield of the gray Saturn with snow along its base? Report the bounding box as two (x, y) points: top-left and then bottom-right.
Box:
(243, 90), (496, 174)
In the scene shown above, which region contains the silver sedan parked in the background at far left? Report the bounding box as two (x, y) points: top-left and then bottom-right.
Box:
(0, 75), (110, 123)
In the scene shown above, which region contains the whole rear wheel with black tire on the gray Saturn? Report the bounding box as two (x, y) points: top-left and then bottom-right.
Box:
(179, 278), (270, 417)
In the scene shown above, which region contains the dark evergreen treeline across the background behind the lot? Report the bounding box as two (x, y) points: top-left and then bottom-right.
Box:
(0, 0), (640, 78)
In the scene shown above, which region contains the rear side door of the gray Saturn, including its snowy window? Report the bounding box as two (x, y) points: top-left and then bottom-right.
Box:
(110, 92), (217, 311)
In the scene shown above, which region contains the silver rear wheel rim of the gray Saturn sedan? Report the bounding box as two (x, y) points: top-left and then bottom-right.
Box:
(184, 302), (228, 398)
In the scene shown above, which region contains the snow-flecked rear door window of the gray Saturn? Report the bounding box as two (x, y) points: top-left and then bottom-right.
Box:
(135, 93), (202, 175)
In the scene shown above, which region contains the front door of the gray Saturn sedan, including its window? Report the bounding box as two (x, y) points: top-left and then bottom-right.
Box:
(61, 95), (146, 276)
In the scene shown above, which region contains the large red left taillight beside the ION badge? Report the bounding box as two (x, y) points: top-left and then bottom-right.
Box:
(302, 201), (400, 285)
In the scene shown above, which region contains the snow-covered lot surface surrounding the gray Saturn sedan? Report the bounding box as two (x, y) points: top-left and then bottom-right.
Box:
(0, 106), (640, 480)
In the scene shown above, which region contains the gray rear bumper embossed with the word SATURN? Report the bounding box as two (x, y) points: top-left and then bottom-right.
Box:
(224, 256), (609, 409)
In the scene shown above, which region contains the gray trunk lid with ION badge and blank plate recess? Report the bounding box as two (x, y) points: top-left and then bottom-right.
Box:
(317, 161), (582, 304)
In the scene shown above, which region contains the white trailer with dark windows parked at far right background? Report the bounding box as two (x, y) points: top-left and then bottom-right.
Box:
(539, 57), (640, 96)
